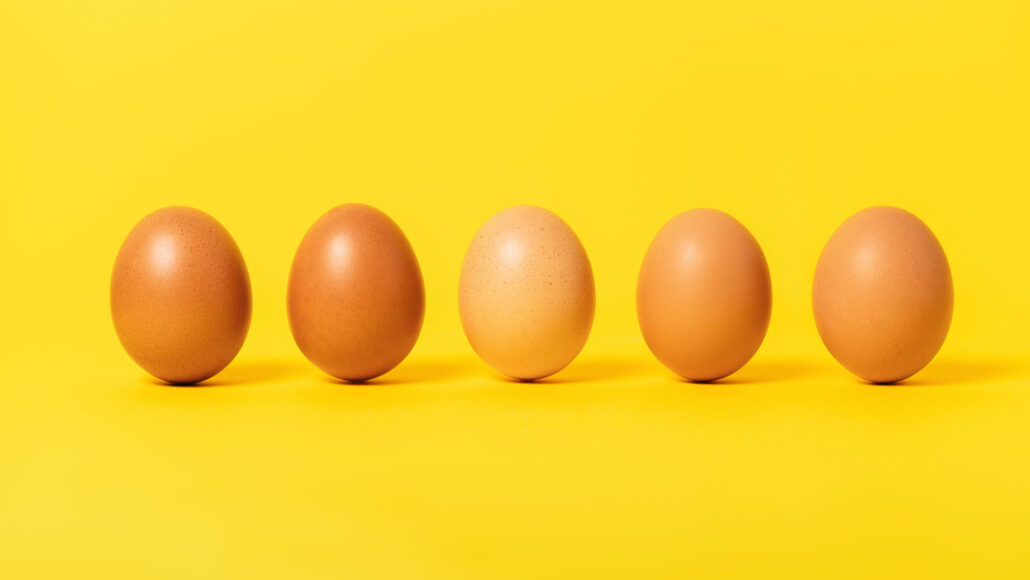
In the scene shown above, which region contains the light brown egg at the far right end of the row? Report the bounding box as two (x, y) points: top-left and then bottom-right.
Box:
(812, 207), (954, 382)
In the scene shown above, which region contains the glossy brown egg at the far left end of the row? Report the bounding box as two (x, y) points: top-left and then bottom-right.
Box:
(111, 207), (250, 384)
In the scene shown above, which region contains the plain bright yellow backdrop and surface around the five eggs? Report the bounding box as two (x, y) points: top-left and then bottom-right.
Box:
(0, 0), (1030, 578)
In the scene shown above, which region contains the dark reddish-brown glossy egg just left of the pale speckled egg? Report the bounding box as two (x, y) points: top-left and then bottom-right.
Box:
(287, 204), (425, 381)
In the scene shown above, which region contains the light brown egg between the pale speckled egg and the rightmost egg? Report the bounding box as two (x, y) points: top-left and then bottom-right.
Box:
(637, 209), (773, 381)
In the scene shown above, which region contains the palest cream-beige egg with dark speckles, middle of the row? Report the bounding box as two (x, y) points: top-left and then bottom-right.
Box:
(458, 205), (594, 380)
